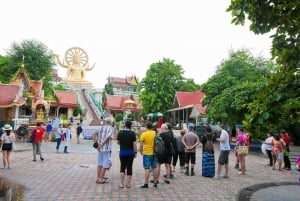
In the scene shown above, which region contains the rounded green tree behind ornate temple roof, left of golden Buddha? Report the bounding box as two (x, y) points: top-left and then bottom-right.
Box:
(7, 40), (55, 97)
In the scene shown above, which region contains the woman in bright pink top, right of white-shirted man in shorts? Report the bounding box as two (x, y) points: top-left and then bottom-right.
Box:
(235, 128), (246, 175)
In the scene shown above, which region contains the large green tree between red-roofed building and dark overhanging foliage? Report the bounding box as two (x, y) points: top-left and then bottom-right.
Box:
(201, 50), (269, 130)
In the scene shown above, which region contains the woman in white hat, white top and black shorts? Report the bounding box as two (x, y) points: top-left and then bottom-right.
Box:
(1, 124), (16, 169)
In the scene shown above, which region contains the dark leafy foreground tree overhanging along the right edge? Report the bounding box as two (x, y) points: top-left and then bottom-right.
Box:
(227, 0), (300, 139)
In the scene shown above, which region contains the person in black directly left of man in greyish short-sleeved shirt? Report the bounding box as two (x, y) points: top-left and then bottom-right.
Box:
(173, 130), (185, 172)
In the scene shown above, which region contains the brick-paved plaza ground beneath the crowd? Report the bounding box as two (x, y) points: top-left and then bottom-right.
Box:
(0, 131), (299, 201)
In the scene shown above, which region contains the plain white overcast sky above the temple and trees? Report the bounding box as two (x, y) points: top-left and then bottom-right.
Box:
(0, 0), (271, 88)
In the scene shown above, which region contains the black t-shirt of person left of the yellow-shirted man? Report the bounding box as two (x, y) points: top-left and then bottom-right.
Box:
(117, 130), (136, 150)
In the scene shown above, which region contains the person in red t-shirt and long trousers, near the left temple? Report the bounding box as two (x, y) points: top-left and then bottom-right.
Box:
(32, 122), (45, 162)
